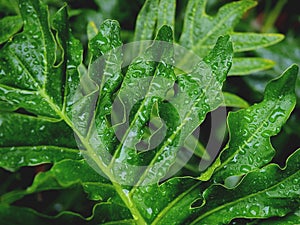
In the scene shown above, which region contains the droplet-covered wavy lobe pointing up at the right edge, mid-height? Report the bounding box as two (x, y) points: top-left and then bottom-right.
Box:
(202, 65), (298, 182)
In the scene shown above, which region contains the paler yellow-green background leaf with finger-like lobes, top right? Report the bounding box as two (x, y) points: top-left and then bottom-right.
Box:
(134, 0), (283, 75)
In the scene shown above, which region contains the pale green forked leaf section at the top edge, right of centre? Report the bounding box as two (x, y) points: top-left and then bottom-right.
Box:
(179, 0), (256, 53)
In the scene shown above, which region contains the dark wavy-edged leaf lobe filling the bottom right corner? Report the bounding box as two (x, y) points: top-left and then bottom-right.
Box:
(189, 149), (300, 224)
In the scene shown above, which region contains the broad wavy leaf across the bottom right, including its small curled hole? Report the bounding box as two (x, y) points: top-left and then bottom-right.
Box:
(120, 150), (300, 224)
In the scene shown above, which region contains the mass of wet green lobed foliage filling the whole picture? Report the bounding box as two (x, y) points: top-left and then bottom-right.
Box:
(0, 0), (300, 225)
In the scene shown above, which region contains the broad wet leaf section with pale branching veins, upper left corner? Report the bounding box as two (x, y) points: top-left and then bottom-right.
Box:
(0, 1), (82, 119)
